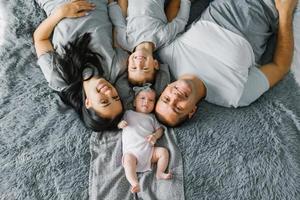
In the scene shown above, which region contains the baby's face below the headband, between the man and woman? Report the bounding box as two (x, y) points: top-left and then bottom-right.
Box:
(134, 90), (155, 113)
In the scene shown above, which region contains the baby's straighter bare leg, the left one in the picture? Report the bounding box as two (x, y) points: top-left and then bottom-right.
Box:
(123, 153), (140, 193)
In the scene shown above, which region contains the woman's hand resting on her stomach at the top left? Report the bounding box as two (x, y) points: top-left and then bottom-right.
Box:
(56, 0), (96, 18)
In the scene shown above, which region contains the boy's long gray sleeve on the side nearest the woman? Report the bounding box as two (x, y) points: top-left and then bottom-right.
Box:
(108, 2), (131, 51)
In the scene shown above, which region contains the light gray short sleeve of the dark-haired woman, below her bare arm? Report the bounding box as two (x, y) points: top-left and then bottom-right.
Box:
(37, 51), (67, 91)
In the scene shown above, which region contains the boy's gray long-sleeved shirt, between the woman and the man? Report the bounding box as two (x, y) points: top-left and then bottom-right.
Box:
(109, 0), (191, 52)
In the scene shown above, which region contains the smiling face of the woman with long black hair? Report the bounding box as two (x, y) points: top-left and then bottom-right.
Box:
(83, 77), (123, 119)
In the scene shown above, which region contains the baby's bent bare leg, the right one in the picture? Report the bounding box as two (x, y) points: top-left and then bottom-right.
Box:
(151, 147), (172, 179)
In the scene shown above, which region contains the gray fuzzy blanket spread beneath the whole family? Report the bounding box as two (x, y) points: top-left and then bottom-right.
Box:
(0, 0), (300, 200)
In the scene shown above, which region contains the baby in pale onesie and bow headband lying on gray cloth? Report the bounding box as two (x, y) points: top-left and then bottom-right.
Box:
(118, 84), (172, 193)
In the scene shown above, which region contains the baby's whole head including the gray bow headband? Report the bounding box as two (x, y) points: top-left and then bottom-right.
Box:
(133, 83), (156, 114)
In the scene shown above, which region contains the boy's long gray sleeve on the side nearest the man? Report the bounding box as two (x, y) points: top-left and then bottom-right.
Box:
(162, 0), (191, 46)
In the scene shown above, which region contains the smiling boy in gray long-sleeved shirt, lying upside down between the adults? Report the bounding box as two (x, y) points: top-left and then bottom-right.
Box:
(109, 0), (191, 85)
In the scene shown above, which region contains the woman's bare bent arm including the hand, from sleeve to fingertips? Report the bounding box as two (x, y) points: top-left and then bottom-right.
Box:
(33, 0), (95, 57)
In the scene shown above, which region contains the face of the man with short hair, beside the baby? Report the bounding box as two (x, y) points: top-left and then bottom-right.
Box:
(155, 79), (197, 126)
